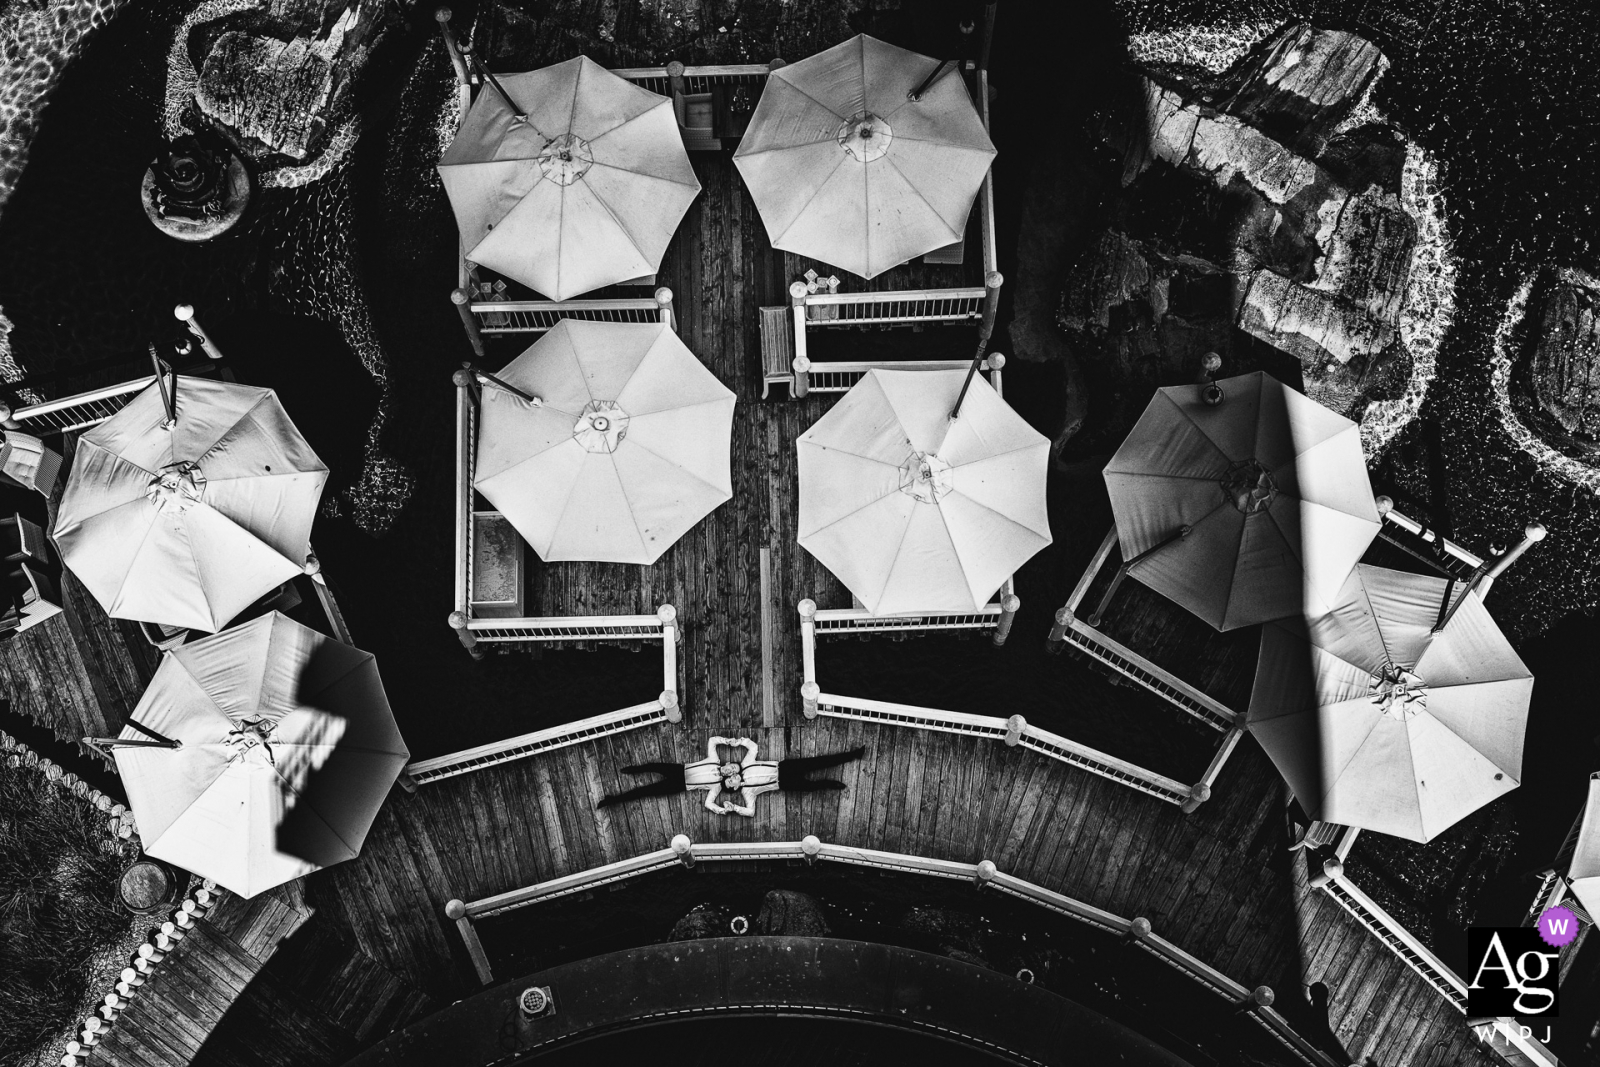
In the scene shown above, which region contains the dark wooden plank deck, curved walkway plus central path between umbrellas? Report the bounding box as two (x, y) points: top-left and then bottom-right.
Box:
(0, 129), (1491, 1067)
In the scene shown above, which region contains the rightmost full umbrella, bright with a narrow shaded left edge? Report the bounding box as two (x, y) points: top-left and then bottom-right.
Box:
(1250, 563), (1533, 841)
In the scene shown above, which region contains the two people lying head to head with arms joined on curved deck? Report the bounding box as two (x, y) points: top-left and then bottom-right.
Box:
(597, 737), (866, 817)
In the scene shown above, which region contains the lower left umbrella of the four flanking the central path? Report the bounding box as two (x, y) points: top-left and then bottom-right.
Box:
(474, 318), (734, 563)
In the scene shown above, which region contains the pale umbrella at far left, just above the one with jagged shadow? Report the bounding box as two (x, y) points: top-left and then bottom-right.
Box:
(54, 376), (328, 630)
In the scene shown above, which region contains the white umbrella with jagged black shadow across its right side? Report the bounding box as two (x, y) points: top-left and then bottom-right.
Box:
(114, 611), (410, 897)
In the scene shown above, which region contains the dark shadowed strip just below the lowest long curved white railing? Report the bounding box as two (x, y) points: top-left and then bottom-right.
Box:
(478, 862), (1307, 1067)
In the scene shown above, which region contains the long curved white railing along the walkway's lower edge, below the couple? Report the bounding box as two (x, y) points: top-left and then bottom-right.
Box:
(445, 833), (1344, 1067)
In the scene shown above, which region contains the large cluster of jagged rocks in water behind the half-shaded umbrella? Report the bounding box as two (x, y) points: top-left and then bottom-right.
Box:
(1059, 24), (1418, 447)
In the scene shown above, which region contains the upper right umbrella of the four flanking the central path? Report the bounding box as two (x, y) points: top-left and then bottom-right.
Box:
(733, 34), (995, 278)
